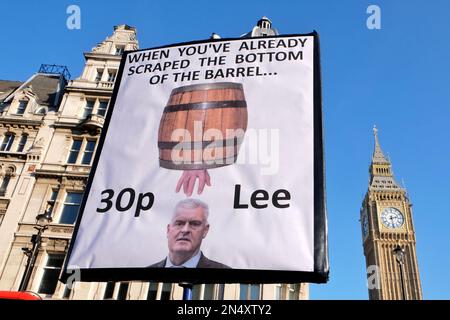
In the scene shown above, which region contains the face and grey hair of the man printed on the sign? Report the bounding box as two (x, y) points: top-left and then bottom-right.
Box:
(167, 207), (209, 257)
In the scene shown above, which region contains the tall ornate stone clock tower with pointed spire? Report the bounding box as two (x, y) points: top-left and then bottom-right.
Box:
(360, 127), (422, 300)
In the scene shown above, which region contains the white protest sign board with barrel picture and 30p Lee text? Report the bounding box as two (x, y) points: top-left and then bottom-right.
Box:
(62, 33), (328, 282)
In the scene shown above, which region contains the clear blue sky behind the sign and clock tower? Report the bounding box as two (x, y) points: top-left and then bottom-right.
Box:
(0, 0), (450, 299)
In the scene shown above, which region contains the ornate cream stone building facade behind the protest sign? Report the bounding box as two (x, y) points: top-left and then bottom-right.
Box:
(0, 25), (308, 299)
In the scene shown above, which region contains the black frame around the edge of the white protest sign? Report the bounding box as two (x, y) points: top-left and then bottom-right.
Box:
(60, 31), (329, 284)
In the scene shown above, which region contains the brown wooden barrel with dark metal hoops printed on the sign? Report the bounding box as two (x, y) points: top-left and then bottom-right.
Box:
(158, 82), (247, 170)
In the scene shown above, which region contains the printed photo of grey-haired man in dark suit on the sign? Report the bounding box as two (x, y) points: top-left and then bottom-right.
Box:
(149, 198), (230, 269)
